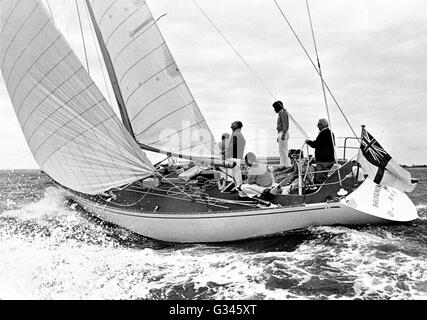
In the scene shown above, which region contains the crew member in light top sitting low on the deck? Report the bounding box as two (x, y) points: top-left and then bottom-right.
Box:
(239, 152), (273, 198)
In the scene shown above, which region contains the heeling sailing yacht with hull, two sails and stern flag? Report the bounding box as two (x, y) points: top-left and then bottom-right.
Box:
(0, 0), (418, 243)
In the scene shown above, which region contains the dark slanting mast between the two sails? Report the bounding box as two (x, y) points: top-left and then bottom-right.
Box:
(85, 0), (136, 140)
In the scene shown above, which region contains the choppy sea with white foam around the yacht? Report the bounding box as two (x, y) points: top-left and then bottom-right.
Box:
(0, 169), (427, 300)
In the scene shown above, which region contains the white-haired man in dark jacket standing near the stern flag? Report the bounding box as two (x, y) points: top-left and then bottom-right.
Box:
(305, 119), (335, 183)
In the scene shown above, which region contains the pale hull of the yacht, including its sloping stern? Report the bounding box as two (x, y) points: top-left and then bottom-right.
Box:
(66, 183), (418, 243)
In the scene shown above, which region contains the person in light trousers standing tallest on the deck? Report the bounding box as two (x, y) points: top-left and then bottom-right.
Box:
(273, 101), (291, 170)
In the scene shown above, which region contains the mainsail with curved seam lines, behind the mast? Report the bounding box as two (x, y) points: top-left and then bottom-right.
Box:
(88, 0), (220, 158)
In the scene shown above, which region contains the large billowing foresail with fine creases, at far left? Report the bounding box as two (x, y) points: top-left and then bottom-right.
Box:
(0, 0), (154, 194)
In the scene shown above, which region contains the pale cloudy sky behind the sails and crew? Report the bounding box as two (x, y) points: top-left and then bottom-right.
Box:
(0, 0), (427, 169)
